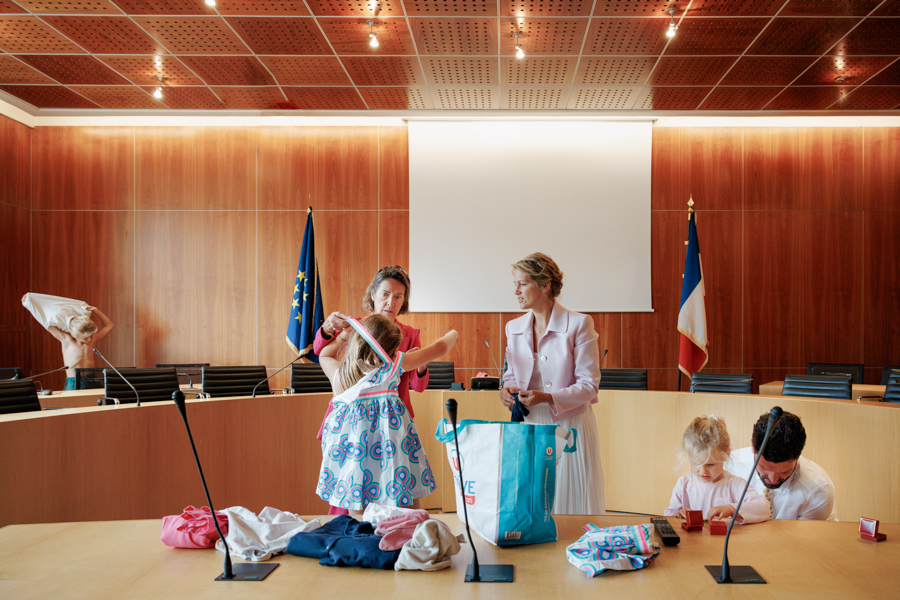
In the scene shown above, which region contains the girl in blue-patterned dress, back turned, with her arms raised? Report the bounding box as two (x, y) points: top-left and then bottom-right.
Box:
(316, 314), (459, 518)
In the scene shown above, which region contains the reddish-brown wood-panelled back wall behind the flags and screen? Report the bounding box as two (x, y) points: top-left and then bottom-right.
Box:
(0, 118), (900, 390)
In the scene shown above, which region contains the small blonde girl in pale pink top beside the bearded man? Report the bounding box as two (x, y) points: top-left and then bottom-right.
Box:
(665, 415), (772, 523)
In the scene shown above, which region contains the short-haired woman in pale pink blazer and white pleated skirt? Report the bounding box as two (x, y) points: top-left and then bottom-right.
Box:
(500, 253), (605, 515)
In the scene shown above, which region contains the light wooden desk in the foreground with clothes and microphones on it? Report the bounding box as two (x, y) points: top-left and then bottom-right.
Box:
(0, 515), (900, 600)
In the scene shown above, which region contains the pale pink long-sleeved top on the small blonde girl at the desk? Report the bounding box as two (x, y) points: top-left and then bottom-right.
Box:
(665, 471), (772, 523)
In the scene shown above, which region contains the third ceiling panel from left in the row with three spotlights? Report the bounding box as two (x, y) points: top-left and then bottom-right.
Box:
(134, 17), (250, 54)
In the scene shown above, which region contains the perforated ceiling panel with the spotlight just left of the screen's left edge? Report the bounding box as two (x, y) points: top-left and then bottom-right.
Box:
(317, 18), (416, 56)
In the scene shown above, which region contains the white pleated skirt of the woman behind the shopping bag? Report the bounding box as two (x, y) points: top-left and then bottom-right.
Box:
(525, 404), (606, 515)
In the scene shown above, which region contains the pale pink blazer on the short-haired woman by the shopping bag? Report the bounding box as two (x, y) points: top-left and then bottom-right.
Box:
(503, 302), (600, 423)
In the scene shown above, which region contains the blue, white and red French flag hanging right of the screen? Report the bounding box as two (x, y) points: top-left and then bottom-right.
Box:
(678, 211), (709, 377)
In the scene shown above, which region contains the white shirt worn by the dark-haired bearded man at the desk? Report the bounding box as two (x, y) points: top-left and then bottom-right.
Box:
(726, 446), (837, 521)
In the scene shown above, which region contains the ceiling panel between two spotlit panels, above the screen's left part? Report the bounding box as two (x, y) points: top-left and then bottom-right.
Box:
(409, 18), (497, 55)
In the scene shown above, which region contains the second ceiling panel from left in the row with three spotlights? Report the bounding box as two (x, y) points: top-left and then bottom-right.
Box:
(41, 16), (166, 54)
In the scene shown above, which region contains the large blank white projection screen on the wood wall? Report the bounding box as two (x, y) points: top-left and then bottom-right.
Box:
(409, 120), (652, 312)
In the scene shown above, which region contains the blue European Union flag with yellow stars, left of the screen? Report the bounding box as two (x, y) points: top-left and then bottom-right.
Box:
(287, 208), (325, 362)
